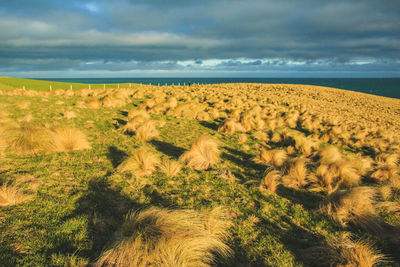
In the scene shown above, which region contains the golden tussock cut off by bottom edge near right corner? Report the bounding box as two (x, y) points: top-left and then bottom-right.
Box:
(305, 233), (385, 267)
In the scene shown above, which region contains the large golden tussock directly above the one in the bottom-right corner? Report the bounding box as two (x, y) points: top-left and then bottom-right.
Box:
(321, 187), (379, 229)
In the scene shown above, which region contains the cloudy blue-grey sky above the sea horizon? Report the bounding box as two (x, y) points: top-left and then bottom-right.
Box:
(0, 0), (400, 78)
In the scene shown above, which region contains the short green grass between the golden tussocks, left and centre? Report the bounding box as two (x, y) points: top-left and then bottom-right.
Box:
(0, 78), (398, 266)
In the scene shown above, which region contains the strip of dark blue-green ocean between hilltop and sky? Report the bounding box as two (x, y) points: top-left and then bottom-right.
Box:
(36, 78), (400, 98)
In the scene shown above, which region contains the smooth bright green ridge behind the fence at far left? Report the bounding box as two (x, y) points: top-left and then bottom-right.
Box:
(0, 77), (134, 91)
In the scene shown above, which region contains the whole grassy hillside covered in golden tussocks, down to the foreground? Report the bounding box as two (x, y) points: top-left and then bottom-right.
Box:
(0, 78), (400, 266)
